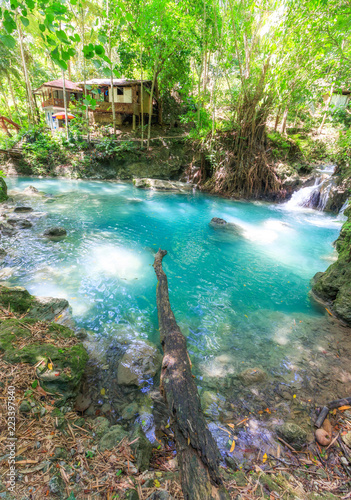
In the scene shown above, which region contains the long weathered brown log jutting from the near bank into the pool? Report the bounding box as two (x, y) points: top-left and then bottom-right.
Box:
(153, 249), (229, 500)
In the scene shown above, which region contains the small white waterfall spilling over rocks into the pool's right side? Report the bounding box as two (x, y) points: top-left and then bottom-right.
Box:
(285, 166), (335, 210)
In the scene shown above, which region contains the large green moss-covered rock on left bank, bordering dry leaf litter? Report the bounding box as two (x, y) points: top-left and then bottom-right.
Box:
(0, 318), (88, 397)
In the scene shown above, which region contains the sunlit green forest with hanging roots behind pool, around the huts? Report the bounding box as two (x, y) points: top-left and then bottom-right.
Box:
(0, 0), (351, 194)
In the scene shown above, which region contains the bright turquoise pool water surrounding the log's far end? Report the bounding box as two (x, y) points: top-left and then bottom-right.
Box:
(3, 178), (341, 382)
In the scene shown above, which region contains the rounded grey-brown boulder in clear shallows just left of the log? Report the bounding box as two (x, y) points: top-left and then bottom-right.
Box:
(117, 340), (162, 386)
